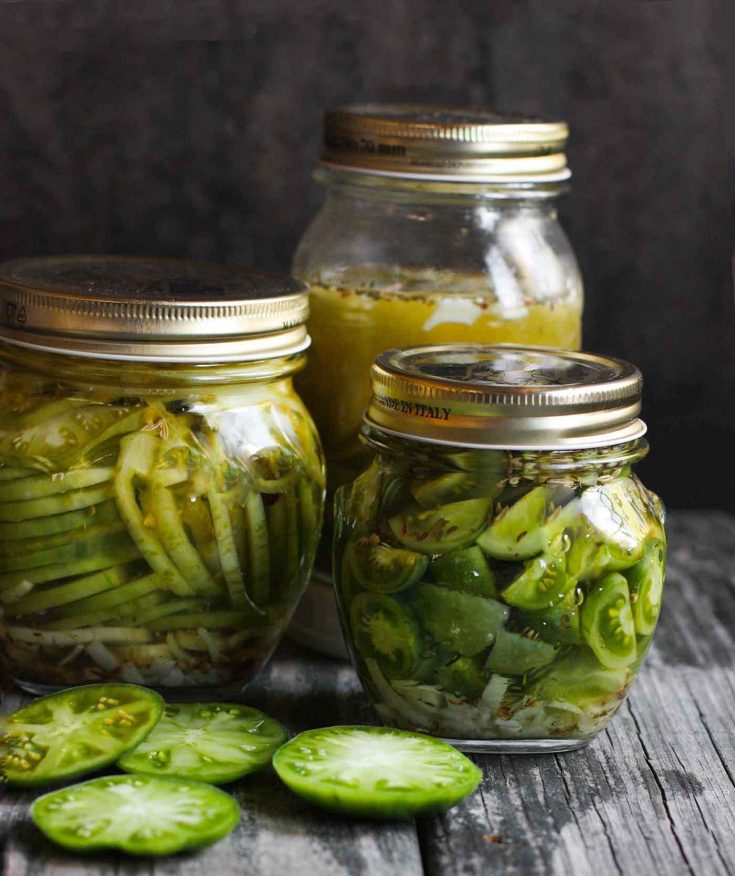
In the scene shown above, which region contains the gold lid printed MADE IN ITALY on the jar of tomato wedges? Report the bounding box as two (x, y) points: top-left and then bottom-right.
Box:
(365, 344), (646, 450)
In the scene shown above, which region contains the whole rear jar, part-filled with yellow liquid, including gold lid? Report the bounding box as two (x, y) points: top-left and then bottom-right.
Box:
(293, 105), (583, 651)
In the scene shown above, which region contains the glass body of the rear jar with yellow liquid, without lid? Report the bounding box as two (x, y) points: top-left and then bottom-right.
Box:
(293, 170), (583, 571)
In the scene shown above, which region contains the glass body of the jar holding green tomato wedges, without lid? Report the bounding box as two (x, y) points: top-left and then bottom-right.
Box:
(334, 434), (666, 751)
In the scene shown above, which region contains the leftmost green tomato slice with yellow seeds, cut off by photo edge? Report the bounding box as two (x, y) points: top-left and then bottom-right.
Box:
(0, 684), (164, 787)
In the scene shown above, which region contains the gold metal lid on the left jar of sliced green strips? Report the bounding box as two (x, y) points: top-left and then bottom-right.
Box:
(0, 256), (309, 363)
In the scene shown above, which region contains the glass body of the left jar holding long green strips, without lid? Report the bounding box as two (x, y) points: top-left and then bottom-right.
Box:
(0, 347), (324, 698)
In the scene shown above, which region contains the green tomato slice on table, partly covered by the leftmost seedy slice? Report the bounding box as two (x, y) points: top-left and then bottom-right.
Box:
(117, 703), (288, 785)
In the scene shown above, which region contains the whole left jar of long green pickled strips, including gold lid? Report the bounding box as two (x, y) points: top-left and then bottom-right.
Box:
(0, 257), (324, 699)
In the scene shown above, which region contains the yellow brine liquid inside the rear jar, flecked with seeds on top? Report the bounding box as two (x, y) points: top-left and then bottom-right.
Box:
(297, 272), (582, 567)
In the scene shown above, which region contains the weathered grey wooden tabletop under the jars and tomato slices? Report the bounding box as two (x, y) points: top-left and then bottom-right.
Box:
(0, 513), (735, 876)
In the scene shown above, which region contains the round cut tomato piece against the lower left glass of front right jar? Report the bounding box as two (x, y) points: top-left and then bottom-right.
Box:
(350, 592), (419, 678)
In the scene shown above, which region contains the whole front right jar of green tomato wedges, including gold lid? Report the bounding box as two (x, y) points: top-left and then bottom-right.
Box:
(334, 345), (666, 752)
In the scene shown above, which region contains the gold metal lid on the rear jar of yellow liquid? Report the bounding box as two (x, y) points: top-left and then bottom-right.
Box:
(321, 104), (571, 184)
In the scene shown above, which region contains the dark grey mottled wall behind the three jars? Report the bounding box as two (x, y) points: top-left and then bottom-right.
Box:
(0, 0), (735, 507)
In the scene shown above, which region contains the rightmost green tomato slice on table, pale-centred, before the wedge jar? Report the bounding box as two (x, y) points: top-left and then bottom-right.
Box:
(273, 726), (482, 818)
